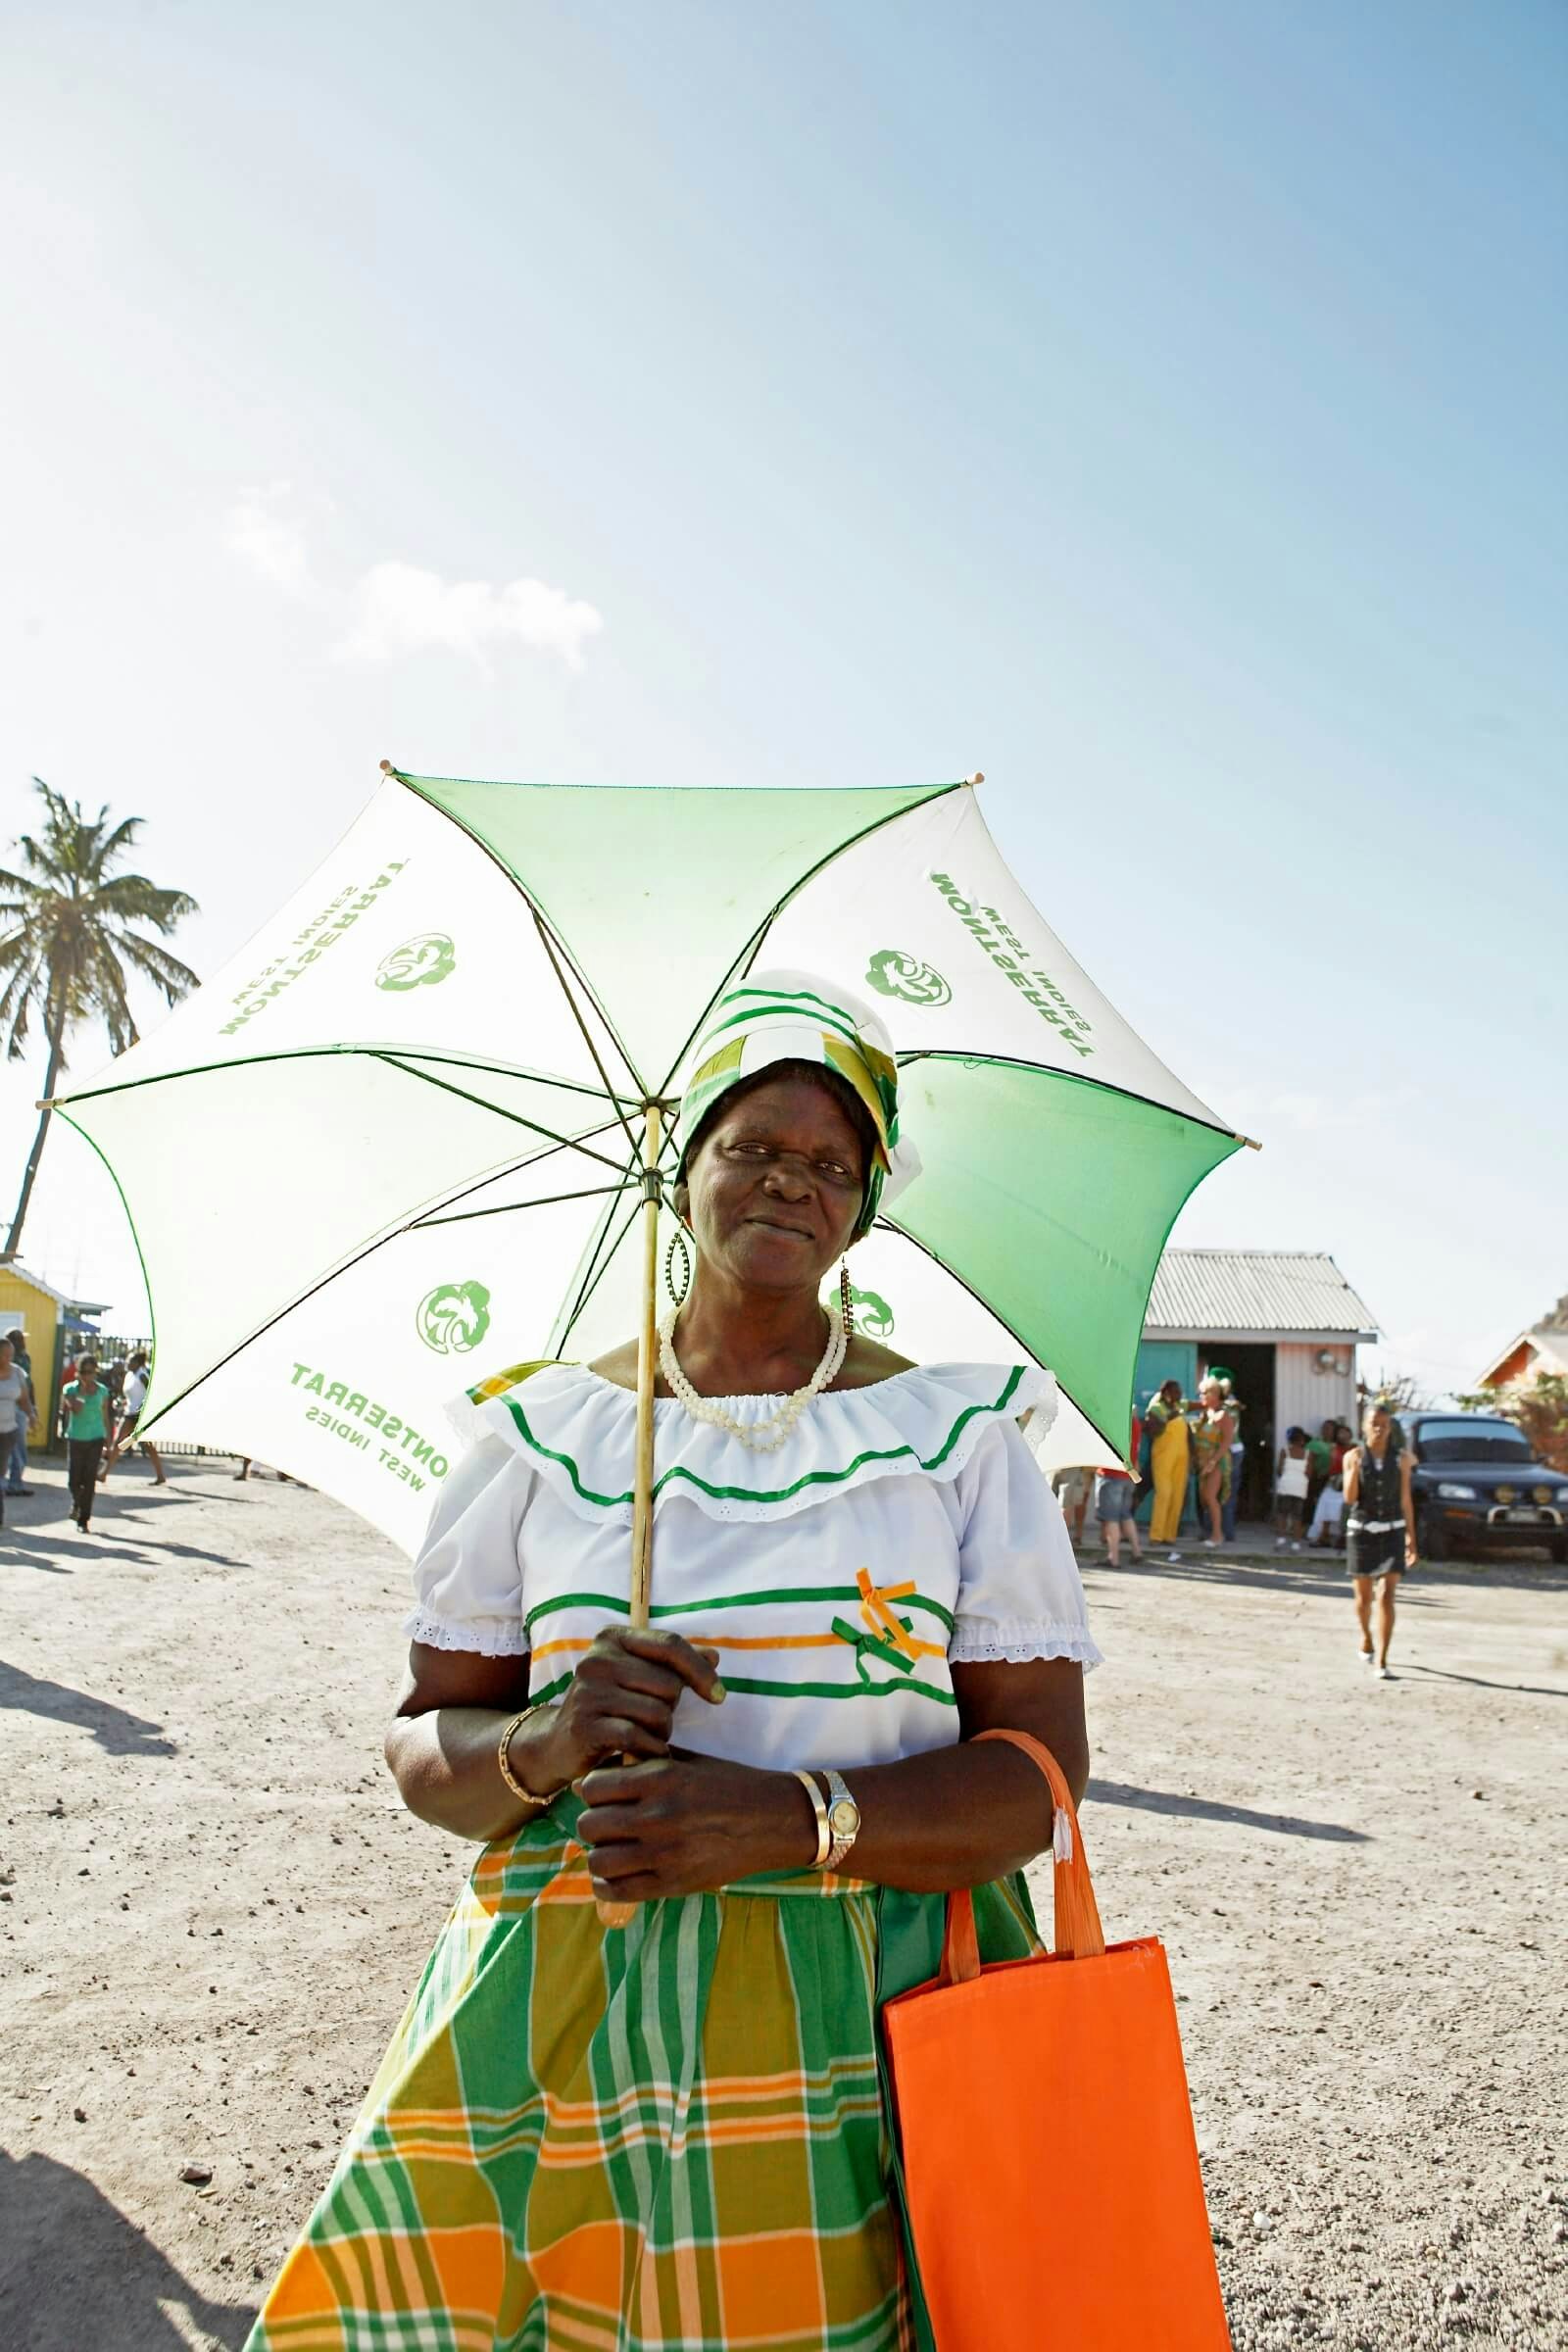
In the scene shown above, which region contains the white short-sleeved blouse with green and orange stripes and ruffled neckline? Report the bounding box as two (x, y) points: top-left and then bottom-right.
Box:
(407, 1364), (1101, 1769)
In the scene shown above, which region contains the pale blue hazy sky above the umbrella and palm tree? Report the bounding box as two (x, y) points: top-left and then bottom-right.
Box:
(0, 0), (1568, 1393)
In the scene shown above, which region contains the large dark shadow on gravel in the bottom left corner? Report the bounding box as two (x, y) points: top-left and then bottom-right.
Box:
(0, 2147), (256, 2352)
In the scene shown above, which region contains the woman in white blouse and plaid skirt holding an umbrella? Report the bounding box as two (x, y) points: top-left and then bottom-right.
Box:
(252, 971), (1098, 2352)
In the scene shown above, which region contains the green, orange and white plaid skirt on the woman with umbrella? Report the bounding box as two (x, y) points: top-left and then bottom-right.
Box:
(247, 1797), (1039, 2352)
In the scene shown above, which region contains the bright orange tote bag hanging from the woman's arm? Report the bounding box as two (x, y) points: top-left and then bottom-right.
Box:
(882, 1731), (1230, 2352)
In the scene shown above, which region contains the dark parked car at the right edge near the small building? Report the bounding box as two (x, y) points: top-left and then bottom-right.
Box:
(1405, 1413), (1568, 1564)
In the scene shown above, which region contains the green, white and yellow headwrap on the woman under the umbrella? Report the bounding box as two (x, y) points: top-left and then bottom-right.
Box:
(679, 971), (919, 1242)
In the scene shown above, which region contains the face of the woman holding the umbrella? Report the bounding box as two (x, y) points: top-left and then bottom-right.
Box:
(674, 1077), (865, 1292)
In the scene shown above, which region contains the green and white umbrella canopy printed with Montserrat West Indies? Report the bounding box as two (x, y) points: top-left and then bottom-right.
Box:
(59, 769), (1242, 1550)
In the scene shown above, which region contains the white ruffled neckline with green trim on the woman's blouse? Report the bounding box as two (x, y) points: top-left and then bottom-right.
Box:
(452, 1364), (1055, 1527)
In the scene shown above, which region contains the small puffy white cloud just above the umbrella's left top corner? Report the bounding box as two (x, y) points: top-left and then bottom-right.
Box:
(336, 563), (604, 670)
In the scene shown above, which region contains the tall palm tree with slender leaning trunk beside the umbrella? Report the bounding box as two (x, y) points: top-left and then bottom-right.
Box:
(0, 776), (197, 1265)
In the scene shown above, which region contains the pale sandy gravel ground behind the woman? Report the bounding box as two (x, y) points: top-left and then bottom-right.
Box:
(0, 1463), (1568, 2352)
